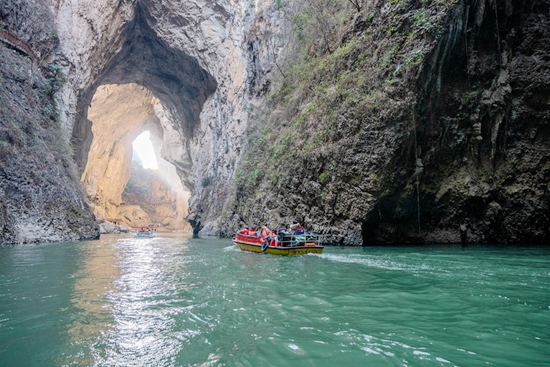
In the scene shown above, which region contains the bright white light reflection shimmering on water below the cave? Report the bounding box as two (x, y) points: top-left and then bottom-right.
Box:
(97, 239), (191, 366)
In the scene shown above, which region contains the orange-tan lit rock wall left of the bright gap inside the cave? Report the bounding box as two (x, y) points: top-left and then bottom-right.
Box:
(81, 84), (160, 221)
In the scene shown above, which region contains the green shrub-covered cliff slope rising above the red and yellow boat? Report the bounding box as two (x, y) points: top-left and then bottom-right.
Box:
(229, 0), (455, 236)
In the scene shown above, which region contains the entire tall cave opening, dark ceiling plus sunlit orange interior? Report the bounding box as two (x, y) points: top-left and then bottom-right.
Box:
(72, 4), (217, 230)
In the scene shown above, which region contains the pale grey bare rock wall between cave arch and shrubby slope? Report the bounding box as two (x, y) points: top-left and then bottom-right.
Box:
(135, 1), (276, 235)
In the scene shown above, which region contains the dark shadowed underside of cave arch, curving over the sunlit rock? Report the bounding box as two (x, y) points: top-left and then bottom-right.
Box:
(71, 3), (217, 190)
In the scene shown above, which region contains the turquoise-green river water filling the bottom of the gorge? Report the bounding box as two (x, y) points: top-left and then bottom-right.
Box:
(0, 236), (550, 367)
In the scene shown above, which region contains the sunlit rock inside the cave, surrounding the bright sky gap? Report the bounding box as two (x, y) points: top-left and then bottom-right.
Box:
(81, 83), (193, 230)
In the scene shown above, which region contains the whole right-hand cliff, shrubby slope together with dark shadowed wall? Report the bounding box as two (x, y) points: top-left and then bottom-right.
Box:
(220, 0), (550, 245)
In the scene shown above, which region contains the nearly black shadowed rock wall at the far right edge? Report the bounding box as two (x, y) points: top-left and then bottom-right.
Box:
(410, 0), (550, 244)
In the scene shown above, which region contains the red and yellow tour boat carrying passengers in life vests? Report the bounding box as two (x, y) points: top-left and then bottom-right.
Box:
(233, 233), (324, 256)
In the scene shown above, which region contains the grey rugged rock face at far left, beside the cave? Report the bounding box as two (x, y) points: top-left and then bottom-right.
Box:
(0, 1), (99, 244)
